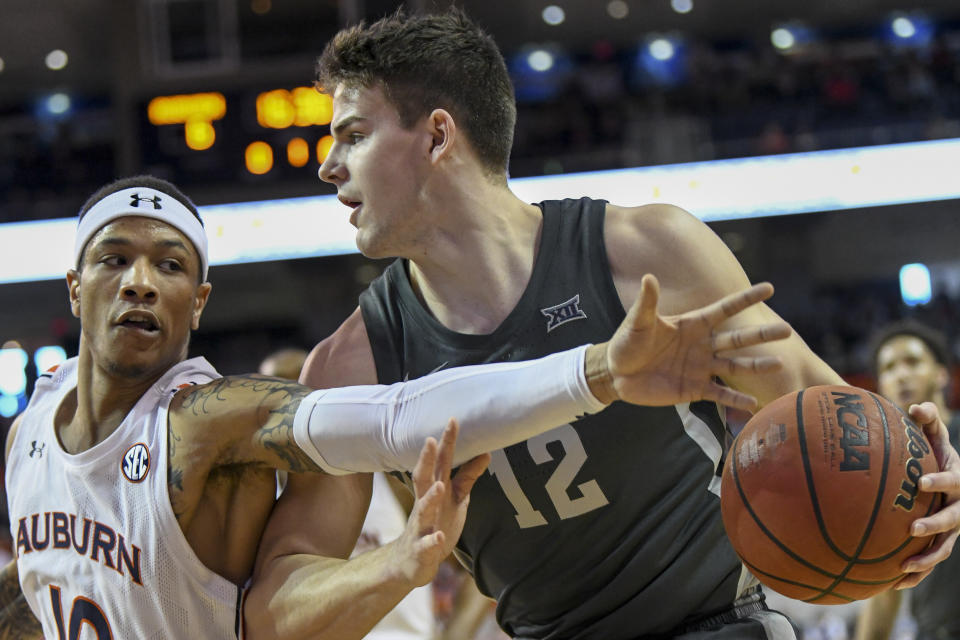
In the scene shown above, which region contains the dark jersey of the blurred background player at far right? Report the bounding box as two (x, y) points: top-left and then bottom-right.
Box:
(910, 413), (960, 639)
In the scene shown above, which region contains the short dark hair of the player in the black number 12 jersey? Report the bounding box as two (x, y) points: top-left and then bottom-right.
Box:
(316, 7), (517, 177)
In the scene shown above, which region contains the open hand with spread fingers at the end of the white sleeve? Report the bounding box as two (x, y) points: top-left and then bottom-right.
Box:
(588, 274), (791, 411)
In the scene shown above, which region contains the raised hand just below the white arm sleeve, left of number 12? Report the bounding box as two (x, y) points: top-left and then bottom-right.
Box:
(395, 419), (490, 586)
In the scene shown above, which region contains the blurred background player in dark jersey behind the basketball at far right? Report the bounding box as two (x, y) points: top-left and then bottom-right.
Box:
(856, 320), (960, 640)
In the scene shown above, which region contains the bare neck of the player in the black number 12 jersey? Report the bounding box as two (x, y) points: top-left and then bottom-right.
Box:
(409, 187), (543, 333)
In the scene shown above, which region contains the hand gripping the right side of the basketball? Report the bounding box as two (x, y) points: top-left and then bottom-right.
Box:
(895, 402), (960, 589)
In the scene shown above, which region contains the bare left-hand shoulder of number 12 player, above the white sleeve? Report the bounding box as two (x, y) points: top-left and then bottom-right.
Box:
(300, 307), (377, 389)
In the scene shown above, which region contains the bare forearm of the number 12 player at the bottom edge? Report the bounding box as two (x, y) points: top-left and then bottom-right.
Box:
(244, 544), (416, 640)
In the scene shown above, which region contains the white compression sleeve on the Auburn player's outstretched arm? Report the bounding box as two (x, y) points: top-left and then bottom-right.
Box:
(293, 347), (606, 474)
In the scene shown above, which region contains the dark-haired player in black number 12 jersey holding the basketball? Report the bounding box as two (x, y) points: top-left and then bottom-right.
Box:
(290, 11), (960, 640)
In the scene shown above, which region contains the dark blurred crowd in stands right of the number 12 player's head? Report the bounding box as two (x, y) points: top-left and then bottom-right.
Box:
(513, 34), (960, 174)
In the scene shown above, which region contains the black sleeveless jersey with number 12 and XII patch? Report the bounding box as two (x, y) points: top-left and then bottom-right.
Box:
(360, 198), (741, 640)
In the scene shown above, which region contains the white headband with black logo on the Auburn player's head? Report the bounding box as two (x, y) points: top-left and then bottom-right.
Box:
(73, 187), (210, 282)
